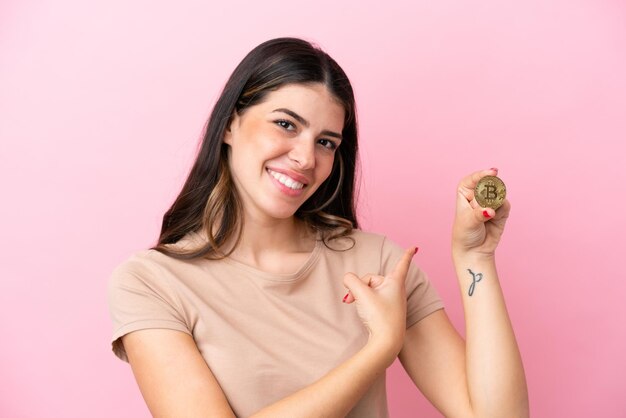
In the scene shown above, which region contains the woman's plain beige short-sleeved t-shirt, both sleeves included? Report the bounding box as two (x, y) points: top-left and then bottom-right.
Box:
(108, 230), (443, 418)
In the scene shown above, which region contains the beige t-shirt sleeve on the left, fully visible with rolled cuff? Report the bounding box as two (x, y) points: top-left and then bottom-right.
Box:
(107, 257), (191, 362)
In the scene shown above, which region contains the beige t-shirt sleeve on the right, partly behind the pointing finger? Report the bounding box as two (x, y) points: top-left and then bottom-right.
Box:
(381, 237), (444, 328)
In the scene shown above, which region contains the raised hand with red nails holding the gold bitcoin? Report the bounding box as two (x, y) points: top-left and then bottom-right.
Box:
(452, 168), (511, 258)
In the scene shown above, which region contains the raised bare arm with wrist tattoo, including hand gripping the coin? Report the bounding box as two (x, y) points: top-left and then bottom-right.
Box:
(399, 169), (529, 418)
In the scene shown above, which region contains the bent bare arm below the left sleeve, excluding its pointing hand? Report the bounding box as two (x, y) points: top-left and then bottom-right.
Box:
(123, 329), (396, 418)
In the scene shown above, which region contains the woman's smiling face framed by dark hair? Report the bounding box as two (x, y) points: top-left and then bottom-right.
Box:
(224, 83), (344, 224)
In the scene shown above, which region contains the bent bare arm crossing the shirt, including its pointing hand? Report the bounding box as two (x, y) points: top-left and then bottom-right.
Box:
(122, 249), (415, 418)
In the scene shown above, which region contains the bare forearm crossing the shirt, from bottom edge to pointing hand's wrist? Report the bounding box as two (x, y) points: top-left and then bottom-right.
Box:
(247, 342), (395, 418)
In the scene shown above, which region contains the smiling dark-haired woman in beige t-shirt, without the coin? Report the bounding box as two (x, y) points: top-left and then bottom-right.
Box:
(109, 38), (528, 418)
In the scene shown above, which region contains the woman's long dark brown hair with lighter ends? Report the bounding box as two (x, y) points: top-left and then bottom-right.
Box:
(152, 38), (358, 259)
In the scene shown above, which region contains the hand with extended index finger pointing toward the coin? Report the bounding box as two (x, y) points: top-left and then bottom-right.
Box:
(343, 247), (417, 364)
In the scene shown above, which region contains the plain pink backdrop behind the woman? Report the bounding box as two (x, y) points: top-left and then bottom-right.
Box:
(0, 0), (626, 418)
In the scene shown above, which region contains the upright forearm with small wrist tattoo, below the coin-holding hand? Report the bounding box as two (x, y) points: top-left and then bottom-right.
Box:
(454, 255), (528, 418)
